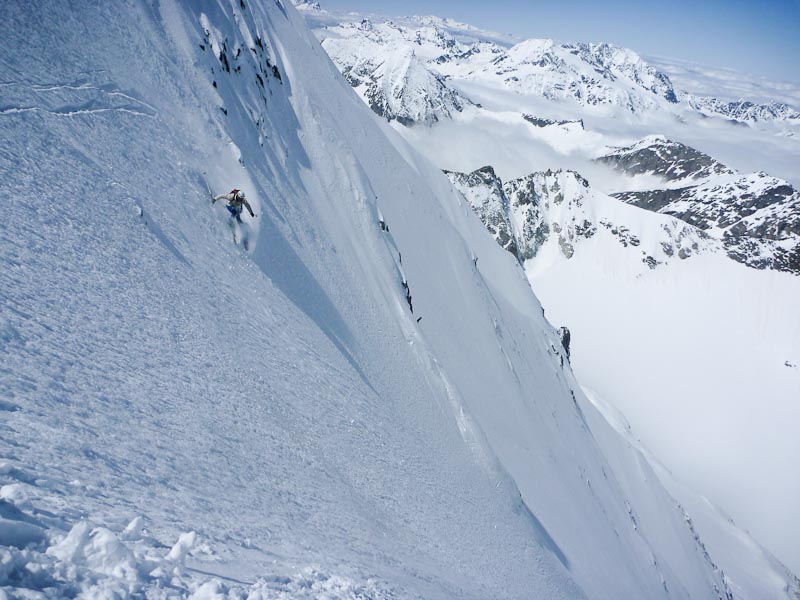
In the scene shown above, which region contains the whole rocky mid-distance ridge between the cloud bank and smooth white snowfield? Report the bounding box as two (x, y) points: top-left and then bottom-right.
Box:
(447, 146), (800, 274)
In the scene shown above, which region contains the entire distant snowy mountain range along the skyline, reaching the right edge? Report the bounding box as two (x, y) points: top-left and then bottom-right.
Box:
(299, 7), (800, 129)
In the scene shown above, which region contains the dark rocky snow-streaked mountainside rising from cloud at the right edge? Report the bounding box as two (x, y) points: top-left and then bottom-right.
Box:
(597, 137), (800, 274)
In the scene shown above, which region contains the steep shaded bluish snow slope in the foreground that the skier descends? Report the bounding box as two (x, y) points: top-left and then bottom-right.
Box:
(0, 0), (726, 599)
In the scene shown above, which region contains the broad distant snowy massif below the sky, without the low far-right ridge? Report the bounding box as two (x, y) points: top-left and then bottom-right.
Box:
(318, 18), (677, 116)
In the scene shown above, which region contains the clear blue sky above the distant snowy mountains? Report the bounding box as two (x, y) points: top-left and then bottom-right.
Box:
(320, 0), (800, 83)
